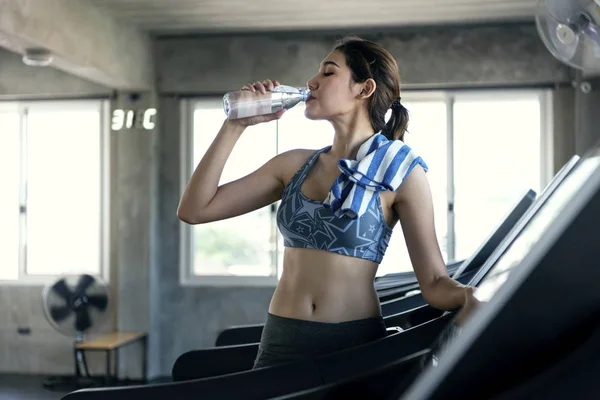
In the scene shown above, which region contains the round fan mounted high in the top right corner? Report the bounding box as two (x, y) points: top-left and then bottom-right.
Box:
(535, 0), (600, 72)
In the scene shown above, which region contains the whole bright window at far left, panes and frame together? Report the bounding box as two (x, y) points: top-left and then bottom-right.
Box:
(0, 101), (108, 282)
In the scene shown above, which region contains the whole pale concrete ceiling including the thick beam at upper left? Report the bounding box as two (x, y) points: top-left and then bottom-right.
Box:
(0, 0), (540, 90)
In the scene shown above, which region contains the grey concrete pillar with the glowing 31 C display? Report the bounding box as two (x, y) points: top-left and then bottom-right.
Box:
(110, 92), (159, 379)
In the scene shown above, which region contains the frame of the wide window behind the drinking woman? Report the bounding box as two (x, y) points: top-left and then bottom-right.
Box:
(179, 88), (554, 288)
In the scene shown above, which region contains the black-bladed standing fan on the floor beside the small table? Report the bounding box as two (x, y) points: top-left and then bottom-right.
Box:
(42, 274), (109, 388)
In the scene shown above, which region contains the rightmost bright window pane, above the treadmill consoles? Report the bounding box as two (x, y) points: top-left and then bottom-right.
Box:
(454, 95), (541, 259)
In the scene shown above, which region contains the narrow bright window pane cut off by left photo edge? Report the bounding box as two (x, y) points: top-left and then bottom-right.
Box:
(0, 113), (21, 280)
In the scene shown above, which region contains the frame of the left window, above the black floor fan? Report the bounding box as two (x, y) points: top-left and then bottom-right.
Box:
(0, 99), (111, 286)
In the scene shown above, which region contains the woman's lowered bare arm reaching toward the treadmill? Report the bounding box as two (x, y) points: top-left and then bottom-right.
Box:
(394, 165), (474, 310)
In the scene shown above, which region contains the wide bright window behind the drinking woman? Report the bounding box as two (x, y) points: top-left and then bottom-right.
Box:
(181, 91), (551, 285)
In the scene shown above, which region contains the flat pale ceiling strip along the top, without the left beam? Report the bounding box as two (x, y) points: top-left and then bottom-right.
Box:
(89, 0), (537, 34)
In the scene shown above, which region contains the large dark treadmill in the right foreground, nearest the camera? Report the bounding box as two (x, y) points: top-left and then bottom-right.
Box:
(274, 148), (600, 400)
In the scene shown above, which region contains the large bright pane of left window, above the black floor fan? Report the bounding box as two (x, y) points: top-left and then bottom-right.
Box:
(27, 105), (101, 275)
